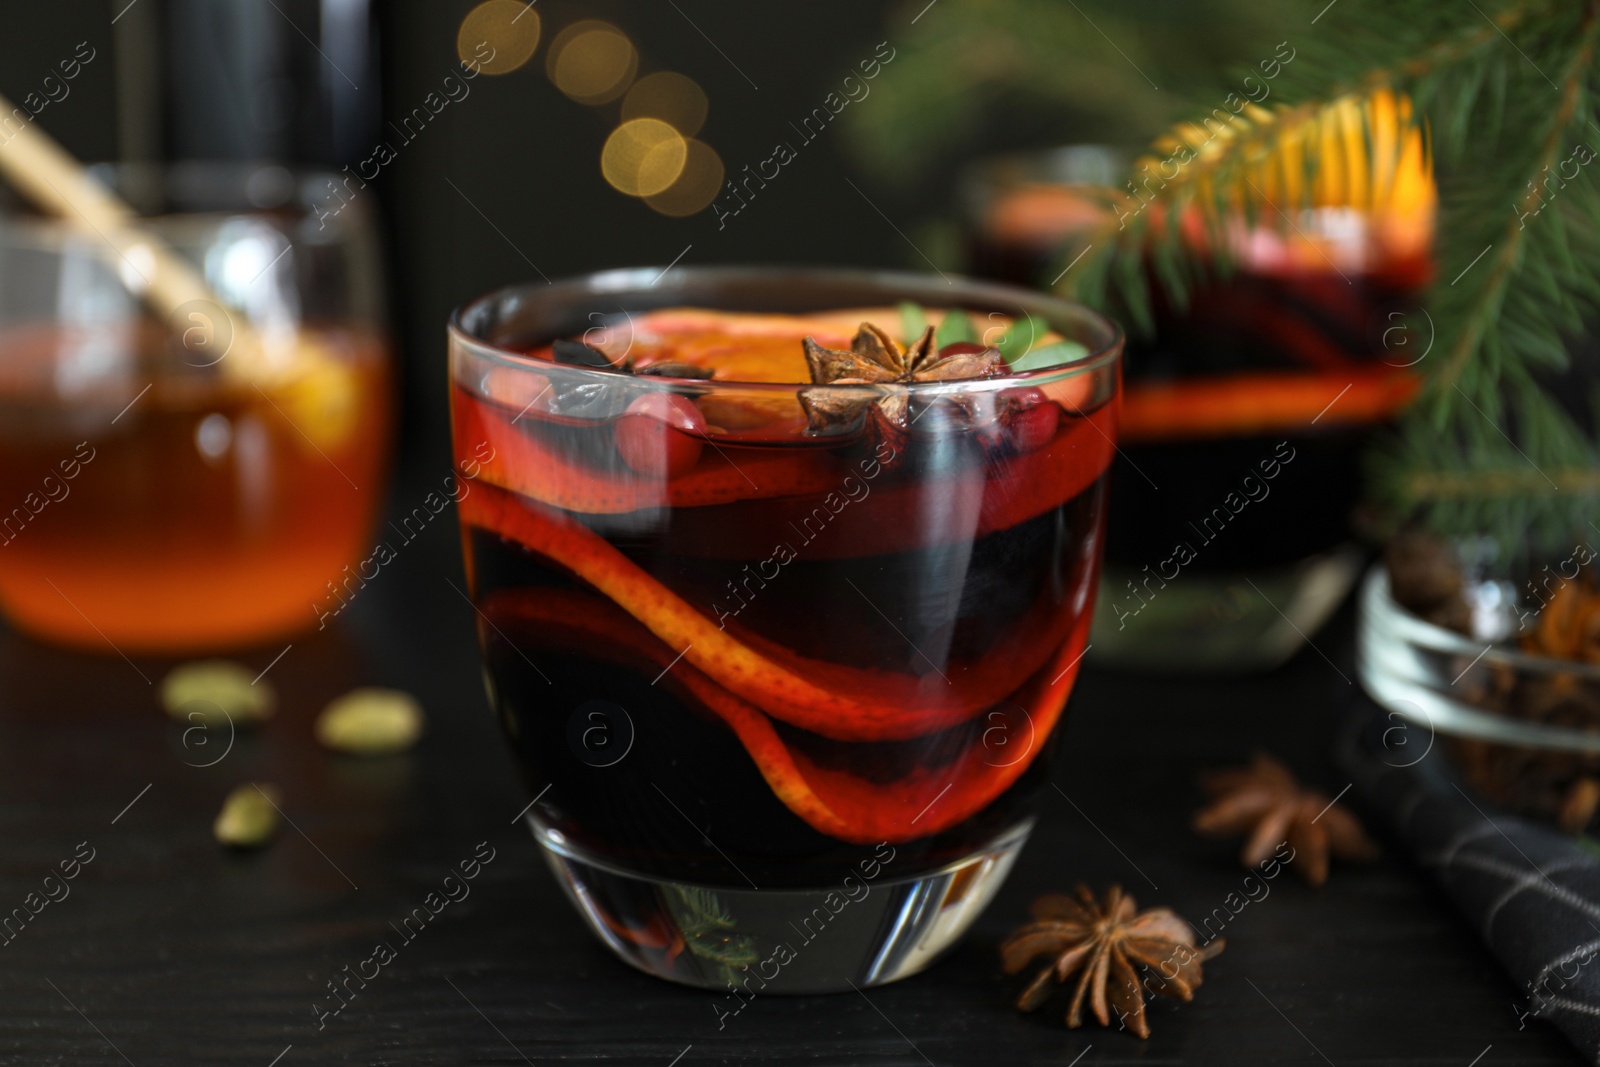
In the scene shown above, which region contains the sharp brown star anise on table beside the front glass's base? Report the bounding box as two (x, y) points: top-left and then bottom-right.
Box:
(1000, 885), (1226, 1038)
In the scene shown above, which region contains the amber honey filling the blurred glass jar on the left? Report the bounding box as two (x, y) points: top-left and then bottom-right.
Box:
(0, 326), (389, 654)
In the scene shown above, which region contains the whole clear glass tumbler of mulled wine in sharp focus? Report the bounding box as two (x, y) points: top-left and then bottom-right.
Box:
(450, 267), (1122, 991)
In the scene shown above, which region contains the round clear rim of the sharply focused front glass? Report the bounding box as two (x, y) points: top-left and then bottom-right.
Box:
(446, 264), (1126, 394)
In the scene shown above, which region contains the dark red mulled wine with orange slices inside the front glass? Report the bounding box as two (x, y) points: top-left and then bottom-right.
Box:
(451, 271), (1117, 977)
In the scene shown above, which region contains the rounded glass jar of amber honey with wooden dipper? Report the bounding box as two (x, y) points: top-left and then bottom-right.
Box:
(0, 163), (390, 653)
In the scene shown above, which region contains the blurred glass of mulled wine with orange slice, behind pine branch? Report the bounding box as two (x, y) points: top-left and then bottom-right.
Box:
(962, 96), (1437, 672)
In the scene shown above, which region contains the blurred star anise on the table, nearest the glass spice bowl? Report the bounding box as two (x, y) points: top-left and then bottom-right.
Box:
(1194, 752), (1378, 886)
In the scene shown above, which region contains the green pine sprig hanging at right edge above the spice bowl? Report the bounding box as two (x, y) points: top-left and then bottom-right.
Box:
(1286, 0), (1600, 565)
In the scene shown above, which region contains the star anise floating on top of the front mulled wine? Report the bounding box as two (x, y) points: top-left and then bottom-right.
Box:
(800, 316), (1005, 453)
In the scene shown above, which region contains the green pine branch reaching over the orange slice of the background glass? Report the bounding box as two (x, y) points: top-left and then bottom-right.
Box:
(1069, 2), (1600, 558)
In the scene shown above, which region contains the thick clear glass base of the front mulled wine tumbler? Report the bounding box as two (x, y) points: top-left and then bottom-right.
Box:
(528, 814), (1034, 991)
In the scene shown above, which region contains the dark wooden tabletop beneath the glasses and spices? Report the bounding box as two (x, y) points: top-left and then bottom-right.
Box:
(0, 476), (1576, 1067)
